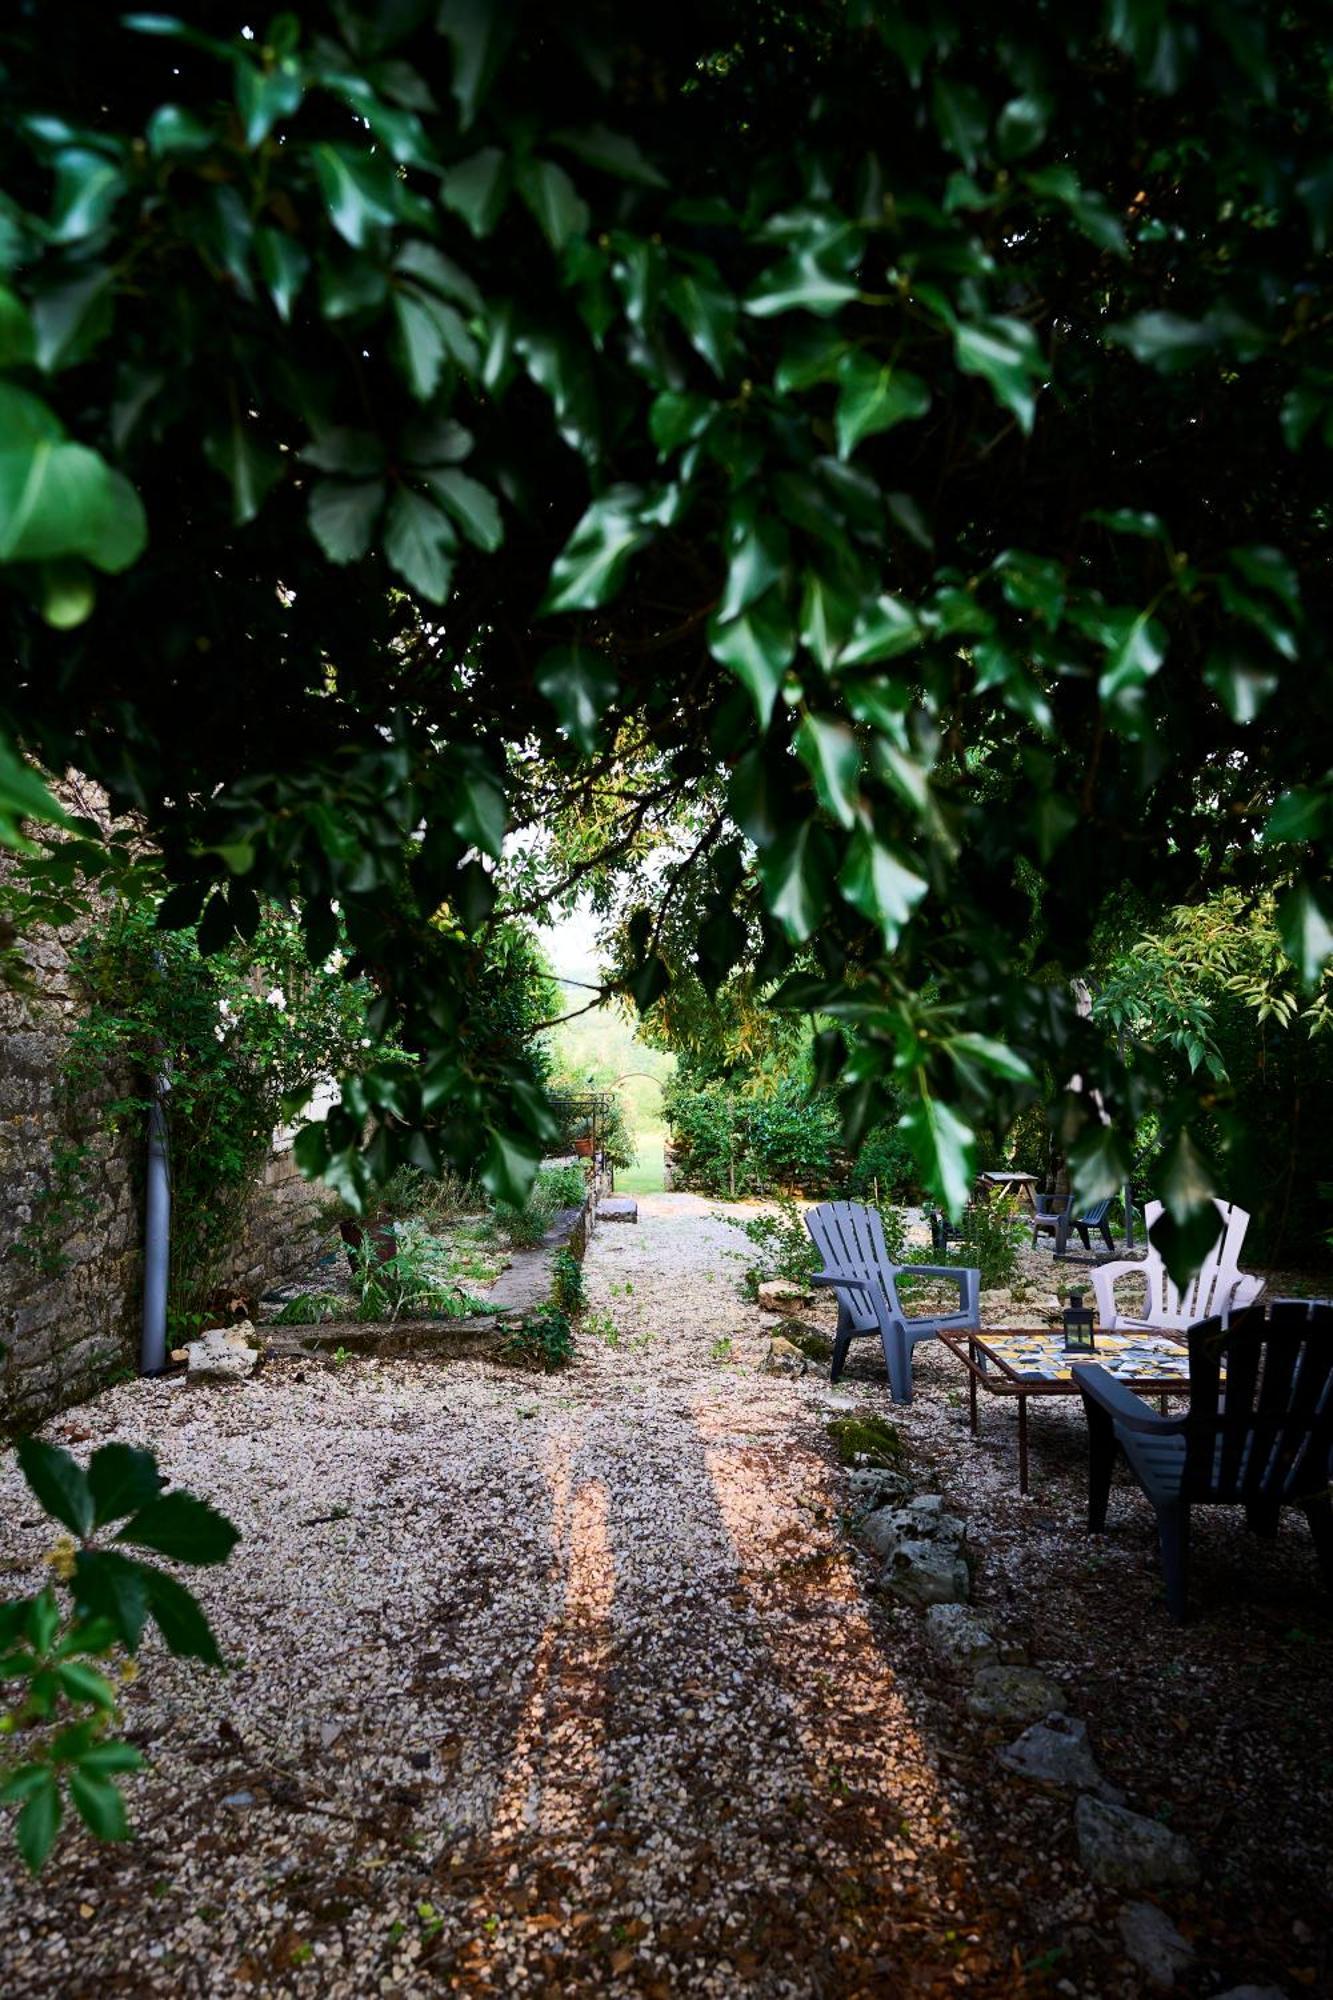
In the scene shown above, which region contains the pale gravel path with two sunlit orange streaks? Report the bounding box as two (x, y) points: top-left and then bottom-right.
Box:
(0, 1194), (1328, 2000)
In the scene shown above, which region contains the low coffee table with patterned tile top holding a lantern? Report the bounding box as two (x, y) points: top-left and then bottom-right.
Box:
(939, 1326), (1189, 1492)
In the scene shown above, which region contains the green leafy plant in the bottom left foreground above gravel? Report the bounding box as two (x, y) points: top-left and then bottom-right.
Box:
(0, 1438), (238, 1872)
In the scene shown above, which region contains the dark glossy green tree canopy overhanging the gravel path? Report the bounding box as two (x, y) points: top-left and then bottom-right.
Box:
(0, 0), (1333, 1260)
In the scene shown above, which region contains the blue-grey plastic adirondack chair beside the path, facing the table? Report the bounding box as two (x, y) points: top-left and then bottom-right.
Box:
(805, 1202), (981, 1402)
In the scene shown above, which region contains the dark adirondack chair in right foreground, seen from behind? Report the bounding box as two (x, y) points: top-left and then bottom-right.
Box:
(1077, 1298), (1333, 1622)
